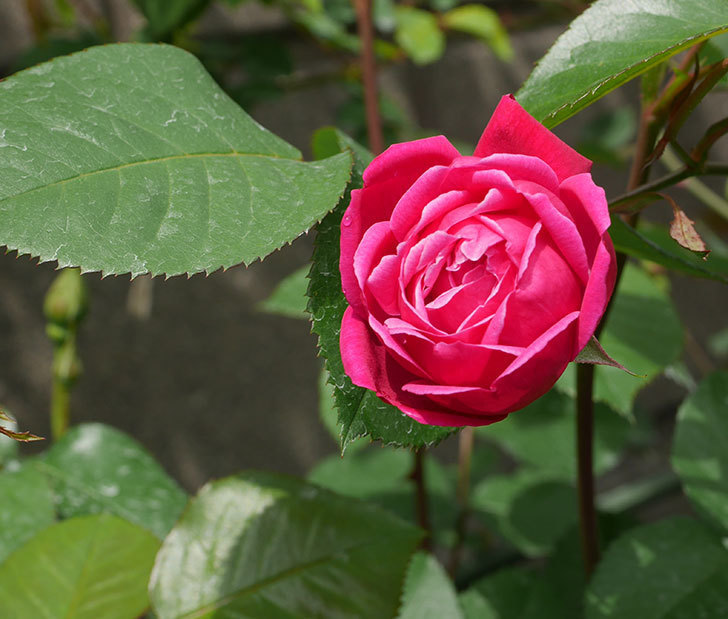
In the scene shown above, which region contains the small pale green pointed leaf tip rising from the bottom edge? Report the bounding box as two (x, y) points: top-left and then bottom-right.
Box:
(397, 552), (464, 619)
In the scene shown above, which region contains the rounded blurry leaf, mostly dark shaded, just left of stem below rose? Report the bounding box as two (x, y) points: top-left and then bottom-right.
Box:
(472, 468), (577, 556)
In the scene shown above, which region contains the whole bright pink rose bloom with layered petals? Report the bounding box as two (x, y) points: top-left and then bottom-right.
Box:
(340, 96), (616, 426)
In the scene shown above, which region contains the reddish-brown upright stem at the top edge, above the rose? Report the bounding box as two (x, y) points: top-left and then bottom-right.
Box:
(353, 0), (384, 155)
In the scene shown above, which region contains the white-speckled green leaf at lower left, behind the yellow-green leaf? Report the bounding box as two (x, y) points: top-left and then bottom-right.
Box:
(39, 423), (187, 539)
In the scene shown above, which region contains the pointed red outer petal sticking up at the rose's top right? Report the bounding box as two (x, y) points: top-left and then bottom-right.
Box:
(474, 95), (591, 181)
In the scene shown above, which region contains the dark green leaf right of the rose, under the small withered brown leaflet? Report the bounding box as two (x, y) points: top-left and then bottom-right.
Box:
(609, 215), (728, 283)
